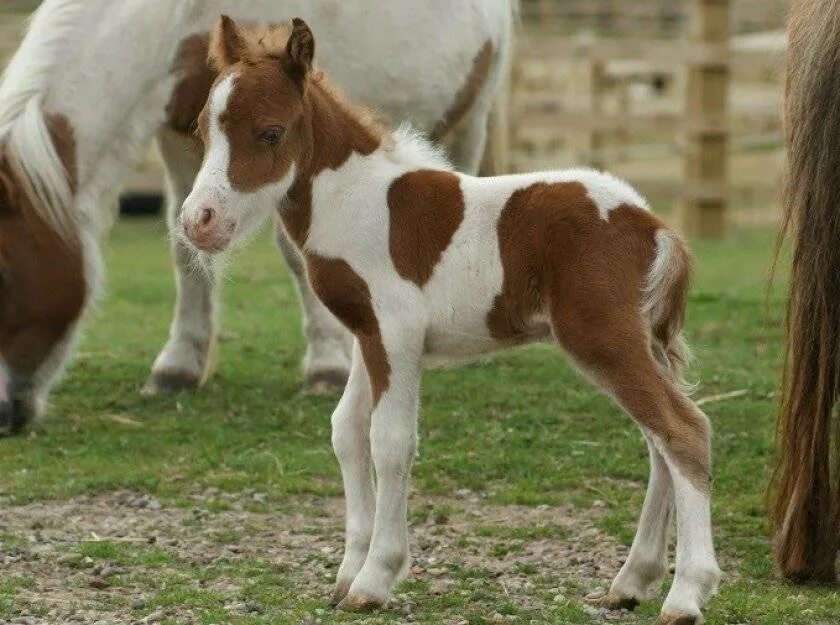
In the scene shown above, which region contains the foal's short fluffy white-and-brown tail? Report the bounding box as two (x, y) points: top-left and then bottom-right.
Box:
(642, 229), (692, 392)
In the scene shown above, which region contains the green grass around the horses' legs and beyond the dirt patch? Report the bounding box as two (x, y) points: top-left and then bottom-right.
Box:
(0, 220), (840, 625)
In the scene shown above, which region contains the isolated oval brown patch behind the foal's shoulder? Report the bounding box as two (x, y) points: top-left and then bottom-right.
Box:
(388, 170), (464, 287)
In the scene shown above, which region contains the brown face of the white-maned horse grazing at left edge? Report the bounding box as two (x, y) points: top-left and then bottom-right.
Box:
(0, 158), (87, 376)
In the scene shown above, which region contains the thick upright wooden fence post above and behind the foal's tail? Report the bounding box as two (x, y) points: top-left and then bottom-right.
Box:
(681, 0), (731, 237)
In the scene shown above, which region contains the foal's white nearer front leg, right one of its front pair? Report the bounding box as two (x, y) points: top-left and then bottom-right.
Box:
(339, 336), (422, 611)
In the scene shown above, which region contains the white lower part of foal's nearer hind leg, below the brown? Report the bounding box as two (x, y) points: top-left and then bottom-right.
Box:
(659, 455), (721, 625)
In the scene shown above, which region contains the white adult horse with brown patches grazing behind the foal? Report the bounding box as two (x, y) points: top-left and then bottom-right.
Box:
(0, 0), (515, 432)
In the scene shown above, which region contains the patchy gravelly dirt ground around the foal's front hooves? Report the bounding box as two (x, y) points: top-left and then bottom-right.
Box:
(0, 490), (626, 625)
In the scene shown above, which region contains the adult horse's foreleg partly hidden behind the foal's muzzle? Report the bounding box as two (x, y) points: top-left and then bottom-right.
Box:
(144, 130), (216, 394)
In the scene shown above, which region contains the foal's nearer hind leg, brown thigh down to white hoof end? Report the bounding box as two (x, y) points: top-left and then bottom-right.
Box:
(554, 320), (720, 625)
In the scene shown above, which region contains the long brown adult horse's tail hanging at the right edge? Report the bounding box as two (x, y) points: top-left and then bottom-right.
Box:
(773, 0), (840, 582)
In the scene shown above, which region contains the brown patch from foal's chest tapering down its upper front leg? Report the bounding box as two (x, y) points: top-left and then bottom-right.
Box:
(306, 253), (391, 407)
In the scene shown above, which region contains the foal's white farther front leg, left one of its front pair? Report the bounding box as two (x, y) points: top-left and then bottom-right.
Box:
(331, 343), (376, 605)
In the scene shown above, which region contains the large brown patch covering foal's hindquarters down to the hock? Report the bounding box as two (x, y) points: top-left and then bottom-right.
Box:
(487, 182), (711, 489)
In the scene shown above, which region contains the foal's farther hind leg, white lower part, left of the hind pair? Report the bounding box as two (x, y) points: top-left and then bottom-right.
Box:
(602, 434), (674, 610)
